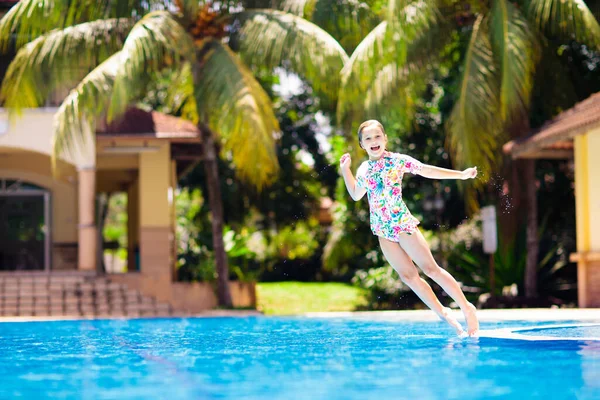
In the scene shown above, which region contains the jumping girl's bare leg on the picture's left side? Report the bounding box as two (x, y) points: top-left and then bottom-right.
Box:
(379, 237), (463, 334)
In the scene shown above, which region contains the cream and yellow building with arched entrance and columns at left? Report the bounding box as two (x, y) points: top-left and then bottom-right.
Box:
(0, 107), (255, 312)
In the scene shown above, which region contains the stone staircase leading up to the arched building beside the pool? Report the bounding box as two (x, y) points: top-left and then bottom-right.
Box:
(0, 274), (180, 318)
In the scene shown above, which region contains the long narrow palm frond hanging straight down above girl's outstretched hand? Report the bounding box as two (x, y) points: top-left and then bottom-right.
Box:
(446, 15), (499, 181)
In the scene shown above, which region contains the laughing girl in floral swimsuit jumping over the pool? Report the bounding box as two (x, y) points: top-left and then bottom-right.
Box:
(340, 120), (479, 336)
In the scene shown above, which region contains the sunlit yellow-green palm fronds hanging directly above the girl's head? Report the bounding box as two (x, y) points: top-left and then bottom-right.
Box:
(283, 0), (446, 142)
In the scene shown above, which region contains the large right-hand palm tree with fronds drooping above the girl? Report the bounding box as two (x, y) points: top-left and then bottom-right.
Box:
(296, 0), (600, 297)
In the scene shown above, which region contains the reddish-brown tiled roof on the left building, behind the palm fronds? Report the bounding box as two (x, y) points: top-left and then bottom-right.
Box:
(96, 107), (200, 140)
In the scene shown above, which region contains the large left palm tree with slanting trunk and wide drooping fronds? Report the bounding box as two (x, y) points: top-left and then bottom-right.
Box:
(0, 0), (348, 306)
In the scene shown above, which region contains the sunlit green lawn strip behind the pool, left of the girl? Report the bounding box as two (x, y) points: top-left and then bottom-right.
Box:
(256, 282), (367, 315)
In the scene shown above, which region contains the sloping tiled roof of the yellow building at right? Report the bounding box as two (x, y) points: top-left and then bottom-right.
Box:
(503, 92), (600, 158)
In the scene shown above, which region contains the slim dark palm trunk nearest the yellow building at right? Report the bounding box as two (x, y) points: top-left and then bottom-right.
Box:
(523, 160), (539, 298)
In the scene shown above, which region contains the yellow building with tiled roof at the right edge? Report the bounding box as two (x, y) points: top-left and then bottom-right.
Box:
(504, 93), (600, 307)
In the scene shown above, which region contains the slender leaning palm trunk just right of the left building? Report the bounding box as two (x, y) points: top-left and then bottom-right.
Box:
(199, 124), (233, 307)
